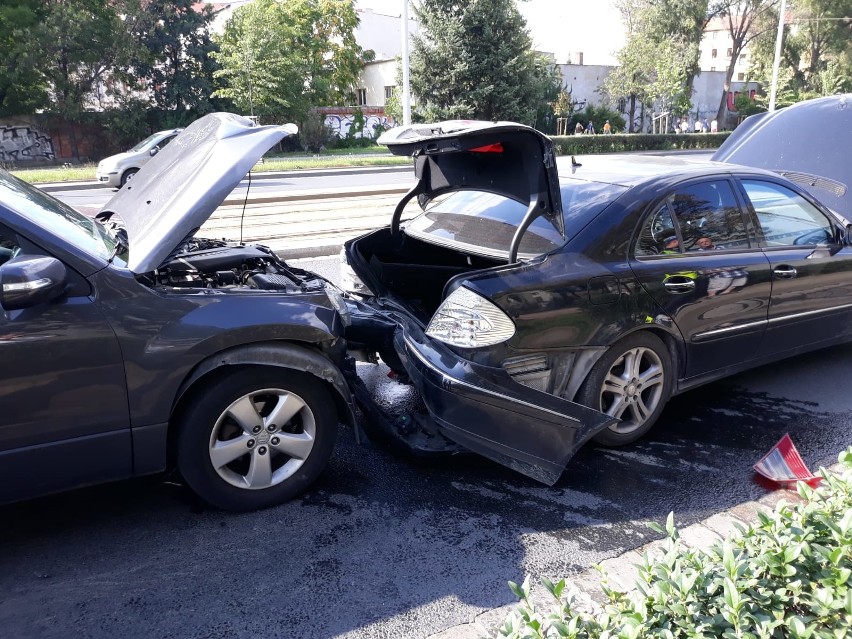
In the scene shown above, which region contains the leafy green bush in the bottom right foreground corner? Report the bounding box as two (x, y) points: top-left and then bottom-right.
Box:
(499, 447), (852, 639)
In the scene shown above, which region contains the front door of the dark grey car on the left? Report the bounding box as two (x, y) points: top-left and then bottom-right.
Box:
(0, 225), (131, 502)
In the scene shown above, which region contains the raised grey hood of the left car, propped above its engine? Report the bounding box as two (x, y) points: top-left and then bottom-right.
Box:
(99, 113), (298, 273)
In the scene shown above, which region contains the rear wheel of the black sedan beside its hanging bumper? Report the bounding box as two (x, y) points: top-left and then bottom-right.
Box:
(577, 332), (674, 446)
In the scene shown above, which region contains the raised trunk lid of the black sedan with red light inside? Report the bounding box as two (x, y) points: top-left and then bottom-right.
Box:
(378, 120), (564, 242)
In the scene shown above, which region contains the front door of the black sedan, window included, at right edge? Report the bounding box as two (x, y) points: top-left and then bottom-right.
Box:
(740, 178), (852, 356)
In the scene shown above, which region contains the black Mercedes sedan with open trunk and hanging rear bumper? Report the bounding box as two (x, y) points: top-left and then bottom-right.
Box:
(345, 96), (852, 483)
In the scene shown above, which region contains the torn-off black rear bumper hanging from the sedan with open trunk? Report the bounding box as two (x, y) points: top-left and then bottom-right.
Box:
(342, 300), (617, 485)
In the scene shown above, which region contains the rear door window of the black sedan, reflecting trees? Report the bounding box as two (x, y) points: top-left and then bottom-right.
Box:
(670, 180), (749, 251)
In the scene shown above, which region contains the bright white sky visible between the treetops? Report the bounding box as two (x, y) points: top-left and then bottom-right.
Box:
(356, 0), (624, 65)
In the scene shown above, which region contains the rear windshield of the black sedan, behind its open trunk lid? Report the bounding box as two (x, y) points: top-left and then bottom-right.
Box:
(405, 179), (626, 258)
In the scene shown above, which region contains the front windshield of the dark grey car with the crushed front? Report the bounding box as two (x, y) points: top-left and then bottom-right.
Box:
(0, 170), (125, 260)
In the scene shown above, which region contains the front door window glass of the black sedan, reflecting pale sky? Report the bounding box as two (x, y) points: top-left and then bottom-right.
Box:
(742, 180), (834, 246)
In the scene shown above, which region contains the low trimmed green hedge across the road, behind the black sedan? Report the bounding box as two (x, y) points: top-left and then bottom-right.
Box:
(551, 132), (730, 155)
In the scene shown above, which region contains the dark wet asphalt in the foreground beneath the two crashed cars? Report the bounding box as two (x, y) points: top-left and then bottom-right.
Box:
(0, 254), (852, 639)
